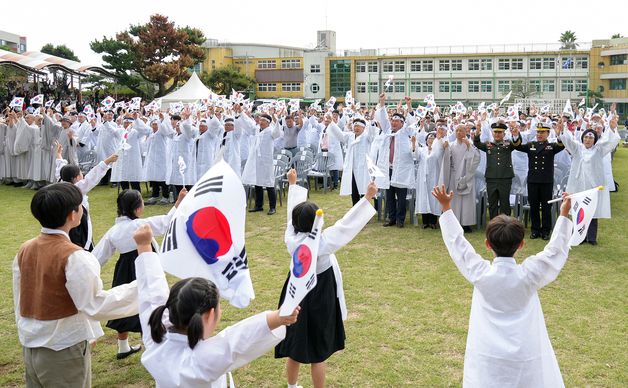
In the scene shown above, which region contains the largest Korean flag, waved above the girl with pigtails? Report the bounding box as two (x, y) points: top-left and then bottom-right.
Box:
(160, 160), (255, 308)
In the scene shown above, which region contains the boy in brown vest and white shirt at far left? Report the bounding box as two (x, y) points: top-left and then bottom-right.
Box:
(13, 182), (138, 387)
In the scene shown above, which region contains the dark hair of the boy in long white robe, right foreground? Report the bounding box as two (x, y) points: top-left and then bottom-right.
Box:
(486, 214), (525, 257)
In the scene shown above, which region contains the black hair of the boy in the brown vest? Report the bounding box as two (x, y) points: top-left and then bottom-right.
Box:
(31, 182), (83, 229)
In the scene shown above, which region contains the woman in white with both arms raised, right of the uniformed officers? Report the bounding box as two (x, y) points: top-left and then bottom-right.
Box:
(557, 117), (621, 245)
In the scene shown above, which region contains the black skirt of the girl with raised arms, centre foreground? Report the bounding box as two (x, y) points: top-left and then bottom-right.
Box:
(275, 267), (345, 364)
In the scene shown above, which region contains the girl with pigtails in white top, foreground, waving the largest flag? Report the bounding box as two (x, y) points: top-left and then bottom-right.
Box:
(133, 225), (299, 388)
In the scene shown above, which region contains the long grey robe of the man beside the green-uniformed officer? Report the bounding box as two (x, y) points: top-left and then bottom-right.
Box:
(441, 140), (480, 226)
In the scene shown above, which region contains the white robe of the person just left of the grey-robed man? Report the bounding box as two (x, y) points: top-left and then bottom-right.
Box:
(414, 139), (445, 216)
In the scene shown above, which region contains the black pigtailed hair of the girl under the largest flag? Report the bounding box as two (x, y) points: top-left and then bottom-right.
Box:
(148, 278), (220, 349)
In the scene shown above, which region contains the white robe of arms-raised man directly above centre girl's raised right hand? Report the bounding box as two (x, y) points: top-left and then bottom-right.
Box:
(327, 123), (377, 195)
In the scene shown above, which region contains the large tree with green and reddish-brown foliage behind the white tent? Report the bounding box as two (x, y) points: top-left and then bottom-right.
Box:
(90, 14), (205, 97)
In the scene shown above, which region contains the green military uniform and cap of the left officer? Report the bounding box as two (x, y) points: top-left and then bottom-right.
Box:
(473, 123), (521, 219)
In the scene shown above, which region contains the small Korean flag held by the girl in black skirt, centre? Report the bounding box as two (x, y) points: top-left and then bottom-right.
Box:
(279, 209), (324, 317)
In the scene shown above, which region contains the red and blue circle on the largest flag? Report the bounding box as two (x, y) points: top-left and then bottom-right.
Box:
(186, 206), (232, 264)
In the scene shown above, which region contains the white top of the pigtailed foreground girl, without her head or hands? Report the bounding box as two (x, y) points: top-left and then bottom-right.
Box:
(135, 252), (286, 388)
